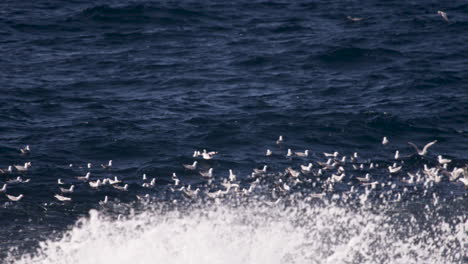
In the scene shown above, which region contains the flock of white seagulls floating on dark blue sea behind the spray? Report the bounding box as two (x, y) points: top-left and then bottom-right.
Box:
(0, 136), (468, 204)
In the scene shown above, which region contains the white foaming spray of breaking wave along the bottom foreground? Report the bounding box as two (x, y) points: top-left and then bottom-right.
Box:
(8, 202), (468, 264)
